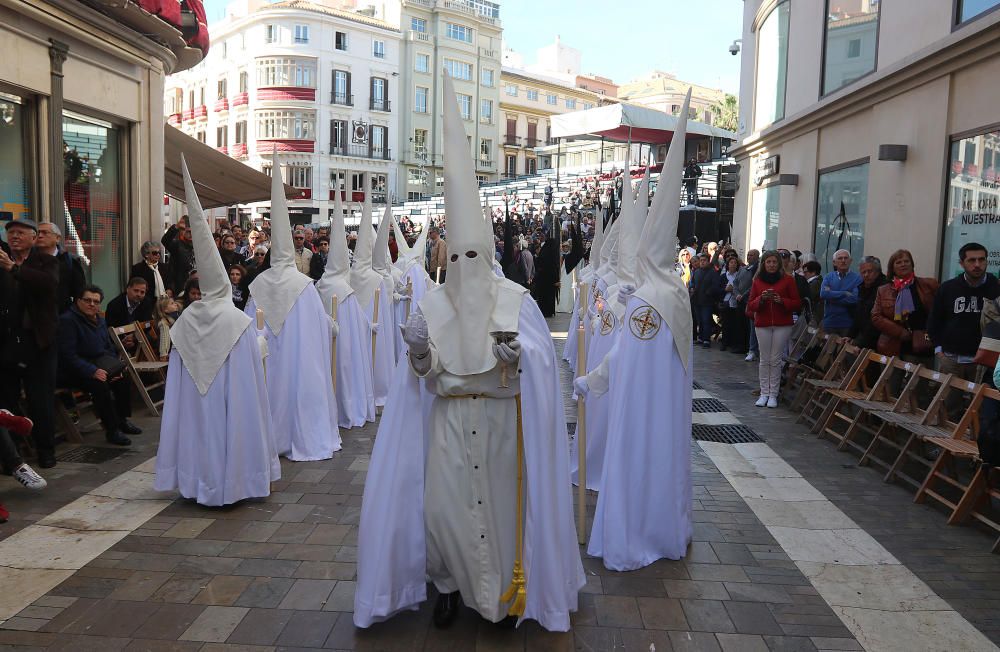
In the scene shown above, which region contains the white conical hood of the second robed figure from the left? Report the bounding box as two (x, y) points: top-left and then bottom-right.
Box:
(250, 146), (312, 335)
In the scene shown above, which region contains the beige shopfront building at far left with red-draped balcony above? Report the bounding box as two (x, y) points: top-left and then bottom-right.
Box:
(0, 0), (208, 296)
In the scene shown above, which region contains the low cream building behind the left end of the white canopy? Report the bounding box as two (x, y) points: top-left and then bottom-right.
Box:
(500, 67), (608, 178)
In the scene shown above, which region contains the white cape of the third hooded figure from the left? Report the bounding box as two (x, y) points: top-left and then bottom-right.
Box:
(335, 294), (375, 428)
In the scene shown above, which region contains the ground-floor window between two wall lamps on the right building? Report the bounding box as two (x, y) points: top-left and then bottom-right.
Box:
(813, 161), (868, 270)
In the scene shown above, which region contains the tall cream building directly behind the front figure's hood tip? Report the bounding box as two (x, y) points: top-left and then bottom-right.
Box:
(396, 0), (501, 199)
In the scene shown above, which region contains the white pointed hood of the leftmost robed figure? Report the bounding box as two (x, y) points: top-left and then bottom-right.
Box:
(170, 154), (251, 396)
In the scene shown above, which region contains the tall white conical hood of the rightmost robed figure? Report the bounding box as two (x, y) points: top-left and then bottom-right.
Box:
(626, 89), (691, 368)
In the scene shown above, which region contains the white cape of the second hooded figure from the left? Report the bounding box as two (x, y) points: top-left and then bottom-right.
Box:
(246, 285), (341, 462)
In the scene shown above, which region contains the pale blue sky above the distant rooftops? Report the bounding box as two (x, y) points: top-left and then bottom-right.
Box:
(205, 0), (743, 95)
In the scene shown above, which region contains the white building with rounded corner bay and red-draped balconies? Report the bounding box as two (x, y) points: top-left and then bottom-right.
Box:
(164, 0), (403, 223)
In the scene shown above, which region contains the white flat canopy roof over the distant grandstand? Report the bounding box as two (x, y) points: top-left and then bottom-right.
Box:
(549, 103), (736, 145)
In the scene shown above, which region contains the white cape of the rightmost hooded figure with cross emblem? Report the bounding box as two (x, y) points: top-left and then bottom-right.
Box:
(587, 295), (693, 571)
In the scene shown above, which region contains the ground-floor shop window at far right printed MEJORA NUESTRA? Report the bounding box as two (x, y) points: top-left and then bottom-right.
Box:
(941, 130), (1000, 278)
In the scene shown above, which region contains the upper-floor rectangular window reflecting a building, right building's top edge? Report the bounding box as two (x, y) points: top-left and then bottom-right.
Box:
(823, 0), (879, 95)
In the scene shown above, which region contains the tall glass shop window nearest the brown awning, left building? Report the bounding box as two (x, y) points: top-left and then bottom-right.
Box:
(59, 111), (128, 299)
